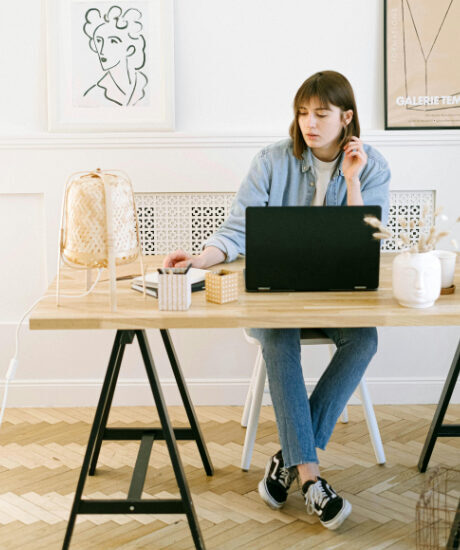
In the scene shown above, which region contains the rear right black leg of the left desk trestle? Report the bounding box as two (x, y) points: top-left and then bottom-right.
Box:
(160, 329), (214, 476)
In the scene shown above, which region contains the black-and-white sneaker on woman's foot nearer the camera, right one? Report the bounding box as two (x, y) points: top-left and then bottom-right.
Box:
(302, 476), (351, 529)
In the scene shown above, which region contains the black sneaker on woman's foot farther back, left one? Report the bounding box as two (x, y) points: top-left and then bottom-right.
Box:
(259, 451), (297, 510)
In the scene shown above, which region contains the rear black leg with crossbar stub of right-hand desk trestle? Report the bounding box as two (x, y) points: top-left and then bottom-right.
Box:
(418, 341), (460, 472)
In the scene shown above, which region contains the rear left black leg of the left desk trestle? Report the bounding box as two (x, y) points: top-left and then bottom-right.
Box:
(89, 330), (134, 476)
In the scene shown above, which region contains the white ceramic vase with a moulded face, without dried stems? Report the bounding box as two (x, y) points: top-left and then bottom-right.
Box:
(393, 252), (441, 308)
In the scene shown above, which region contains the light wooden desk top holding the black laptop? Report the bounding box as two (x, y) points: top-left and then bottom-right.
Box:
(30, 254), (460, 330)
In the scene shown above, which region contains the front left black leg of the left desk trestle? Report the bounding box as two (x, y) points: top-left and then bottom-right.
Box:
(62, 330), (133, 550)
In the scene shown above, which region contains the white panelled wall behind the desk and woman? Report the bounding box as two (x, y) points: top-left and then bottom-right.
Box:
(0, 0), (460, 405)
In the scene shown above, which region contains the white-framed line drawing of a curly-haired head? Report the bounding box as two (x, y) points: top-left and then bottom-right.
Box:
(47, 0), (174, 132)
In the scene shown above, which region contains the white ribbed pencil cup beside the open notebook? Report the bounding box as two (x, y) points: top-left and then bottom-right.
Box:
(158, 268), (192, 311)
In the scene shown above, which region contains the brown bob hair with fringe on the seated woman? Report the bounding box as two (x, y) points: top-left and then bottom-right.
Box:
(289, 71), (360, 160)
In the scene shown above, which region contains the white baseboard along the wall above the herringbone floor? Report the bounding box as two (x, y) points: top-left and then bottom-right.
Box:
(0, 377), (460, 407)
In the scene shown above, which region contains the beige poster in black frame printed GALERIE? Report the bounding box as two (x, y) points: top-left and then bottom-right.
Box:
(384, 0), (460, 130)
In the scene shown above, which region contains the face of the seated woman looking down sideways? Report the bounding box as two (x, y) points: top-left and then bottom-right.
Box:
(298, 98), (344, 153)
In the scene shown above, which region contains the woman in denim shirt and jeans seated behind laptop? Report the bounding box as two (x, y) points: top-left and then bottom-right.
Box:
(164, 71), (390, 529)
